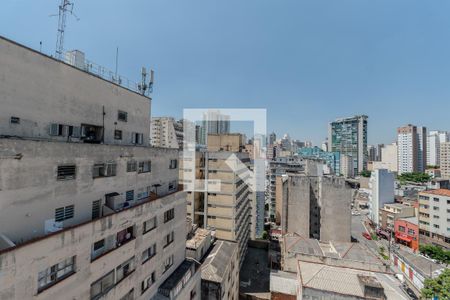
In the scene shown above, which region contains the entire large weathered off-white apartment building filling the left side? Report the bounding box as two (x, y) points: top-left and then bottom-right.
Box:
(0, 37), (201, 299)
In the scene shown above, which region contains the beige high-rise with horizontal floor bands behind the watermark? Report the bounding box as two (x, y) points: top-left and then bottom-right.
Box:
(180, 134), (256, 263)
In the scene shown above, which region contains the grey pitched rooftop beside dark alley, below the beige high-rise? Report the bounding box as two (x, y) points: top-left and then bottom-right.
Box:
(202, 241), (237, 282)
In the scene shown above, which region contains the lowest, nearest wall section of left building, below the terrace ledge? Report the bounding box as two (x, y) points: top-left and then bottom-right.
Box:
(0, 192), (186, 299)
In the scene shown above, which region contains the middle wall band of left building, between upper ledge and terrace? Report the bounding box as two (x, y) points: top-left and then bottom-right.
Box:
(0, 139), (178, 242)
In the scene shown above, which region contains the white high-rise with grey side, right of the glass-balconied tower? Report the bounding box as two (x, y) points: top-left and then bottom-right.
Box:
(397, 124), (427, 174)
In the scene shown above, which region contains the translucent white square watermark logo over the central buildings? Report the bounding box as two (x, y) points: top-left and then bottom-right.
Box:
(182, 108), (267, 193)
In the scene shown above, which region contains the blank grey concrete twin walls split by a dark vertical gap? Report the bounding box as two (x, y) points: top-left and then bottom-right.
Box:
(277, 174), (352, 242)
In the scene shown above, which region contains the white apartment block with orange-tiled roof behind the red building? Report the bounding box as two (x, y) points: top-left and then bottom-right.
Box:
(419, 189), (450, 249)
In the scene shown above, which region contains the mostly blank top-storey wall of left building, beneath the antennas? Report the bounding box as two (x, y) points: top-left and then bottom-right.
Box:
(0, 37), (150, 145)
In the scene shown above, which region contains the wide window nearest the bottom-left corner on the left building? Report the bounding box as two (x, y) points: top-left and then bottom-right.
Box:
(38, 256), (75, 293)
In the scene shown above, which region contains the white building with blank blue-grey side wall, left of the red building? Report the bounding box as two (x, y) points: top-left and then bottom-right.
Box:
(369, 169), (394, 225)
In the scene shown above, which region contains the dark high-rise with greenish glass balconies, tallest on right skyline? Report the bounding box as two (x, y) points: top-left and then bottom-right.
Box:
(328, 115), (368, 175)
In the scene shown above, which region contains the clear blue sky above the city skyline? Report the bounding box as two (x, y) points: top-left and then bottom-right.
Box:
(0, 0), (450, 145)
